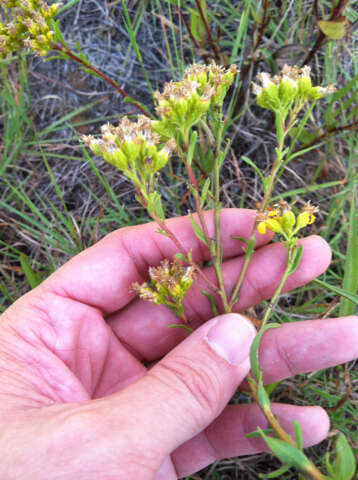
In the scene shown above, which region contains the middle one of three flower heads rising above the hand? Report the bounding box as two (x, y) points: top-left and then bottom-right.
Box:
(154, 63), (237, 138)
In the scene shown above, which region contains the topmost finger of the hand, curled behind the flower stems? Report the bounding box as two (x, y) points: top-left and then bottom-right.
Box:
(42, 209), (272, 314)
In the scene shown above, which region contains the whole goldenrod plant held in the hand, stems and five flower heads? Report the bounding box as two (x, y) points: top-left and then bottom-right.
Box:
(82, 63), (352, 480)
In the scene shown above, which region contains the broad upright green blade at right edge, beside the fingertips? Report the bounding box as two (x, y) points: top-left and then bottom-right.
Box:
(339, 191), (358, 317)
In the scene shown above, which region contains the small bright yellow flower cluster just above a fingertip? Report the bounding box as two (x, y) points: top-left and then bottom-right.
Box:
(256, 200), (318, 240)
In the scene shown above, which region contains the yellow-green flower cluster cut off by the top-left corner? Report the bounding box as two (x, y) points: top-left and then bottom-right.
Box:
(0, 0), (61, 57)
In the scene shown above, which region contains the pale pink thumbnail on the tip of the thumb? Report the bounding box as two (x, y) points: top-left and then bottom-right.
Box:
(205, 313), (257, 365)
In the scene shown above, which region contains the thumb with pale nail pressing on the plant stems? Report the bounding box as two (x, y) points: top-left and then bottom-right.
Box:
(102, 314), (256, 459)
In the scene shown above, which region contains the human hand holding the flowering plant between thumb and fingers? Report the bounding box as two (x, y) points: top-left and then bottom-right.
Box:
(0, 210), (358, 480)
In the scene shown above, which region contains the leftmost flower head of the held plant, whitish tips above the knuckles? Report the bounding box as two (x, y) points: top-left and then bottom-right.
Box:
(82, 115), (175, 187)
